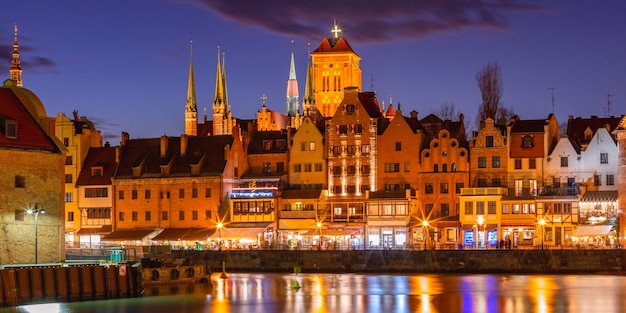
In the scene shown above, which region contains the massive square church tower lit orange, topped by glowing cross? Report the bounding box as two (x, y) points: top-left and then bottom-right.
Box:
(311, 23), (363, 117)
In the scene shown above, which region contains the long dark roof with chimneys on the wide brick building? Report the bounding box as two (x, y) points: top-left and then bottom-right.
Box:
(115, 135), (233, 178)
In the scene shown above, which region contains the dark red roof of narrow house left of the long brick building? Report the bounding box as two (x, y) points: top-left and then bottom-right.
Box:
(76, 147), (117, 186)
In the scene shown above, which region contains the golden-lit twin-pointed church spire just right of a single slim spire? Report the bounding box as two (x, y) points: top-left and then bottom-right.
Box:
(213, 46), (234, 135)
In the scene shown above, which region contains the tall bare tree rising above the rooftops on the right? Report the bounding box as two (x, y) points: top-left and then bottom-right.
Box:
(476, 62), (504, 121)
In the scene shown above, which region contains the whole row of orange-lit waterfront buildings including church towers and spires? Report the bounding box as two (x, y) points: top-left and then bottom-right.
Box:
(0, 24), (626, 263)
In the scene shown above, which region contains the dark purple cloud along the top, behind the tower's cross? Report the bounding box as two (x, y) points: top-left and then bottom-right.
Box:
(175, 0), (544, 43)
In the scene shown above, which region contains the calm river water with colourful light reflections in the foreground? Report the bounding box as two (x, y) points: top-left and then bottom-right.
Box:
(0, 274), (626, 313)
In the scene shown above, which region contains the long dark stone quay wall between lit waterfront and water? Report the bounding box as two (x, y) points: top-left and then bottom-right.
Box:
(172, 250), (626, 273)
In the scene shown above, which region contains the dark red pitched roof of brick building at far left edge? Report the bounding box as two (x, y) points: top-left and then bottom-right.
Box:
(0, 88), (60, 152)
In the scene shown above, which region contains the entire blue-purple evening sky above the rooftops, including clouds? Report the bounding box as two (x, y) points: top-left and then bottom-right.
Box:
(0, 0), (626, 140)
